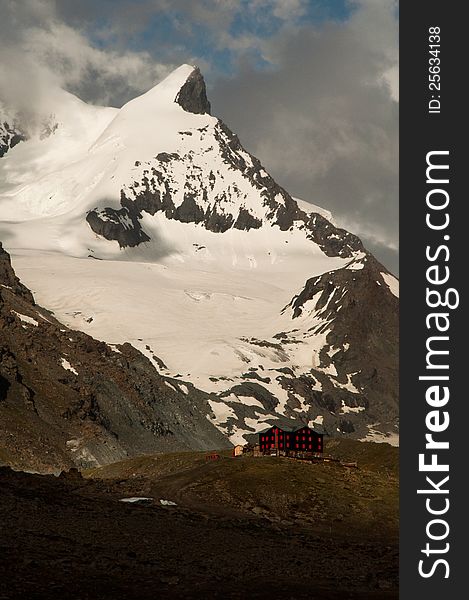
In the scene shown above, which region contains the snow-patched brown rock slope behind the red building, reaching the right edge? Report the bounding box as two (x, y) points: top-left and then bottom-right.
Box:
(206, 253), (399, 443)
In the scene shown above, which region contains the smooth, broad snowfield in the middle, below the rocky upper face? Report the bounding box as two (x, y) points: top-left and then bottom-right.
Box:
(12, 229), (346, 393)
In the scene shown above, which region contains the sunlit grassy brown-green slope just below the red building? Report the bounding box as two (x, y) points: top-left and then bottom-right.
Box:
(85, 440), (399, 539)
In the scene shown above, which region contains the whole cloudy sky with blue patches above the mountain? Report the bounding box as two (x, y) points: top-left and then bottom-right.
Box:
(0, 0), (398, 273)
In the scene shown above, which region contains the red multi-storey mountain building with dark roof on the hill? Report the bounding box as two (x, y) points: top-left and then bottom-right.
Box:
(259, 425), (324, 454)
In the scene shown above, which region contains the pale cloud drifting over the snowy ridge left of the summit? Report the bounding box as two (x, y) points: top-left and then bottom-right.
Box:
(0, 1), (172, 120)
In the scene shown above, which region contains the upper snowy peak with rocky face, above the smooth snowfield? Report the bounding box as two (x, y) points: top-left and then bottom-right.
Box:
(0, 65), (362, 268)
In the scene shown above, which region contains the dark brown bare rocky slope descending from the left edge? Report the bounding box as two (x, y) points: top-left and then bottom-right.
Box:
(0, 249), (229, 471)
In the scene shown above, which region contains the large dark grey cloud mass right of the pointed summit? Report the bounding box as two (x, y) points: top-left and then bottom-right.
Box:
(211, 3), (398, 272)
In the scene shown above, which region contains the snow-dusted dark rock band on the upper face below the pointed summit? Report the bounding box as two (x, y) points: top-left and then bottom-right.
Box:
(86, 116), (363, 258)
